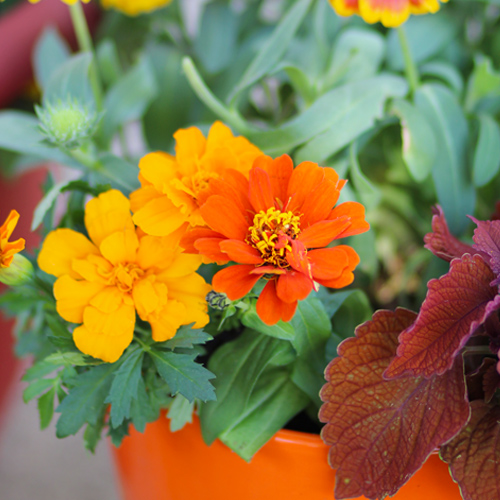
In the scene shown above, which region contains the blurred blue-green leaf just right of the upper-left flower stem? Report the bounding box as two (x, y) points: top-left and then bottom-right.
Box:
(100, 56), (158, 142)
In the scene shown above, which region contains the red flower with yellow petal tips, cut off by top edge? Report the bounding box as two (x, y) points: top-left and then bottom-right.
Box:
(329, 0), (448, 28)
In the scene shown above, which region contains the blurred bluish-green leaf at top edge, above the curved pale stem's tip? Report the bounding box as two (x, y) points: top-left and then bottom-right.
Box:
(194, 2), (239, 73)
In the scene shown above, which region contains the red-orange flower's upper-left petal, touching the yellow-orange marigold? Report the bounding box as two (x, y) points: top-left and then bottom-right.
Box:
(201, 196), (248, 240)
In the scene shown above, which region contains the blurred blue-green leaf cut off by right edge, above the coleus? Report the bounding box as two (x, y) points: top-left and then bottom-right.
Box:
(472, 114), (500, 187)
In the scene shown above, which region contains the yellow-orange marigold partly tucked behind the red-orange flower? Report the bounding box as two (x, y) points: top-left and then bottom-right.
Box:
(130, 122), (263, 236)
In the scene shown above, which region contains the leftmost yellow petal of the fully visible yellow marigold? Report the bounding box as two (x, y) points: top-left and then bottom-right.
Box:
(38, 228), (99, 278)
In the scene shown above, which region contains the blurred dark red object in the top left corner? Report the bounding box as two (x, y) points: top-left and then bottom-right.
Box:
(0, 0), (100, 107)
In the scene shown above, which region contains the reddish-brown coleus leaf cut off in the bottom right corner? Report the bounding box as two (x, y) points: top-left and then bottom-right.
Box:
(440, 401), (500, 500)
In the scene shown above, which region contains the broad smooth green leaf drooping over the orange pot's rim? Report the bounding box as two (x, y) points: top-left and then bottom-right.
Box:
(200, 330), (290, 444)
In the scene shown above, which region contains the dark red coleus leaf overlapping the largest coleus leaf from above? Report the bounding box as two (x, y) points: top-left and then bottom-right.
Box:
(385, 254), (500, 378)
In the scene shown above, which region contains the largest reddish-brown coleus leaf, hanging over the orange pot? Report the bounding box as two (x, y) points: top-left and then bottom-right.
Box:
(320, 309), (469, 499)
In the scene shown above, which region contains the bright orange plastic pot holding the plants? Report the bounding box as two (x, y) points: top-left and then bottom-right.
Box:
(113, 418), (461, 500)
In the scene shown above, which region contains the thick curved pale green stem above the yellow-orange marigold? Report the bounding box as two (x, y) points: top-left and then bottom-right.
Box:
(182, 57), (253, 135)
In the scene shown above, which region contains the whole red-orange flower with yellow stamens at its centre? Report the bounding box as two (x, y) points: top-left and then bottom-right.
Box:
(181, 155), (369, 325)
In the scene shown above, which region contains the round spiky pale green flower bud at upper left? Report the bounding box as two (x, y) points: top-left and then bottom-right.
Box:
(35, 99), (98, 149)
